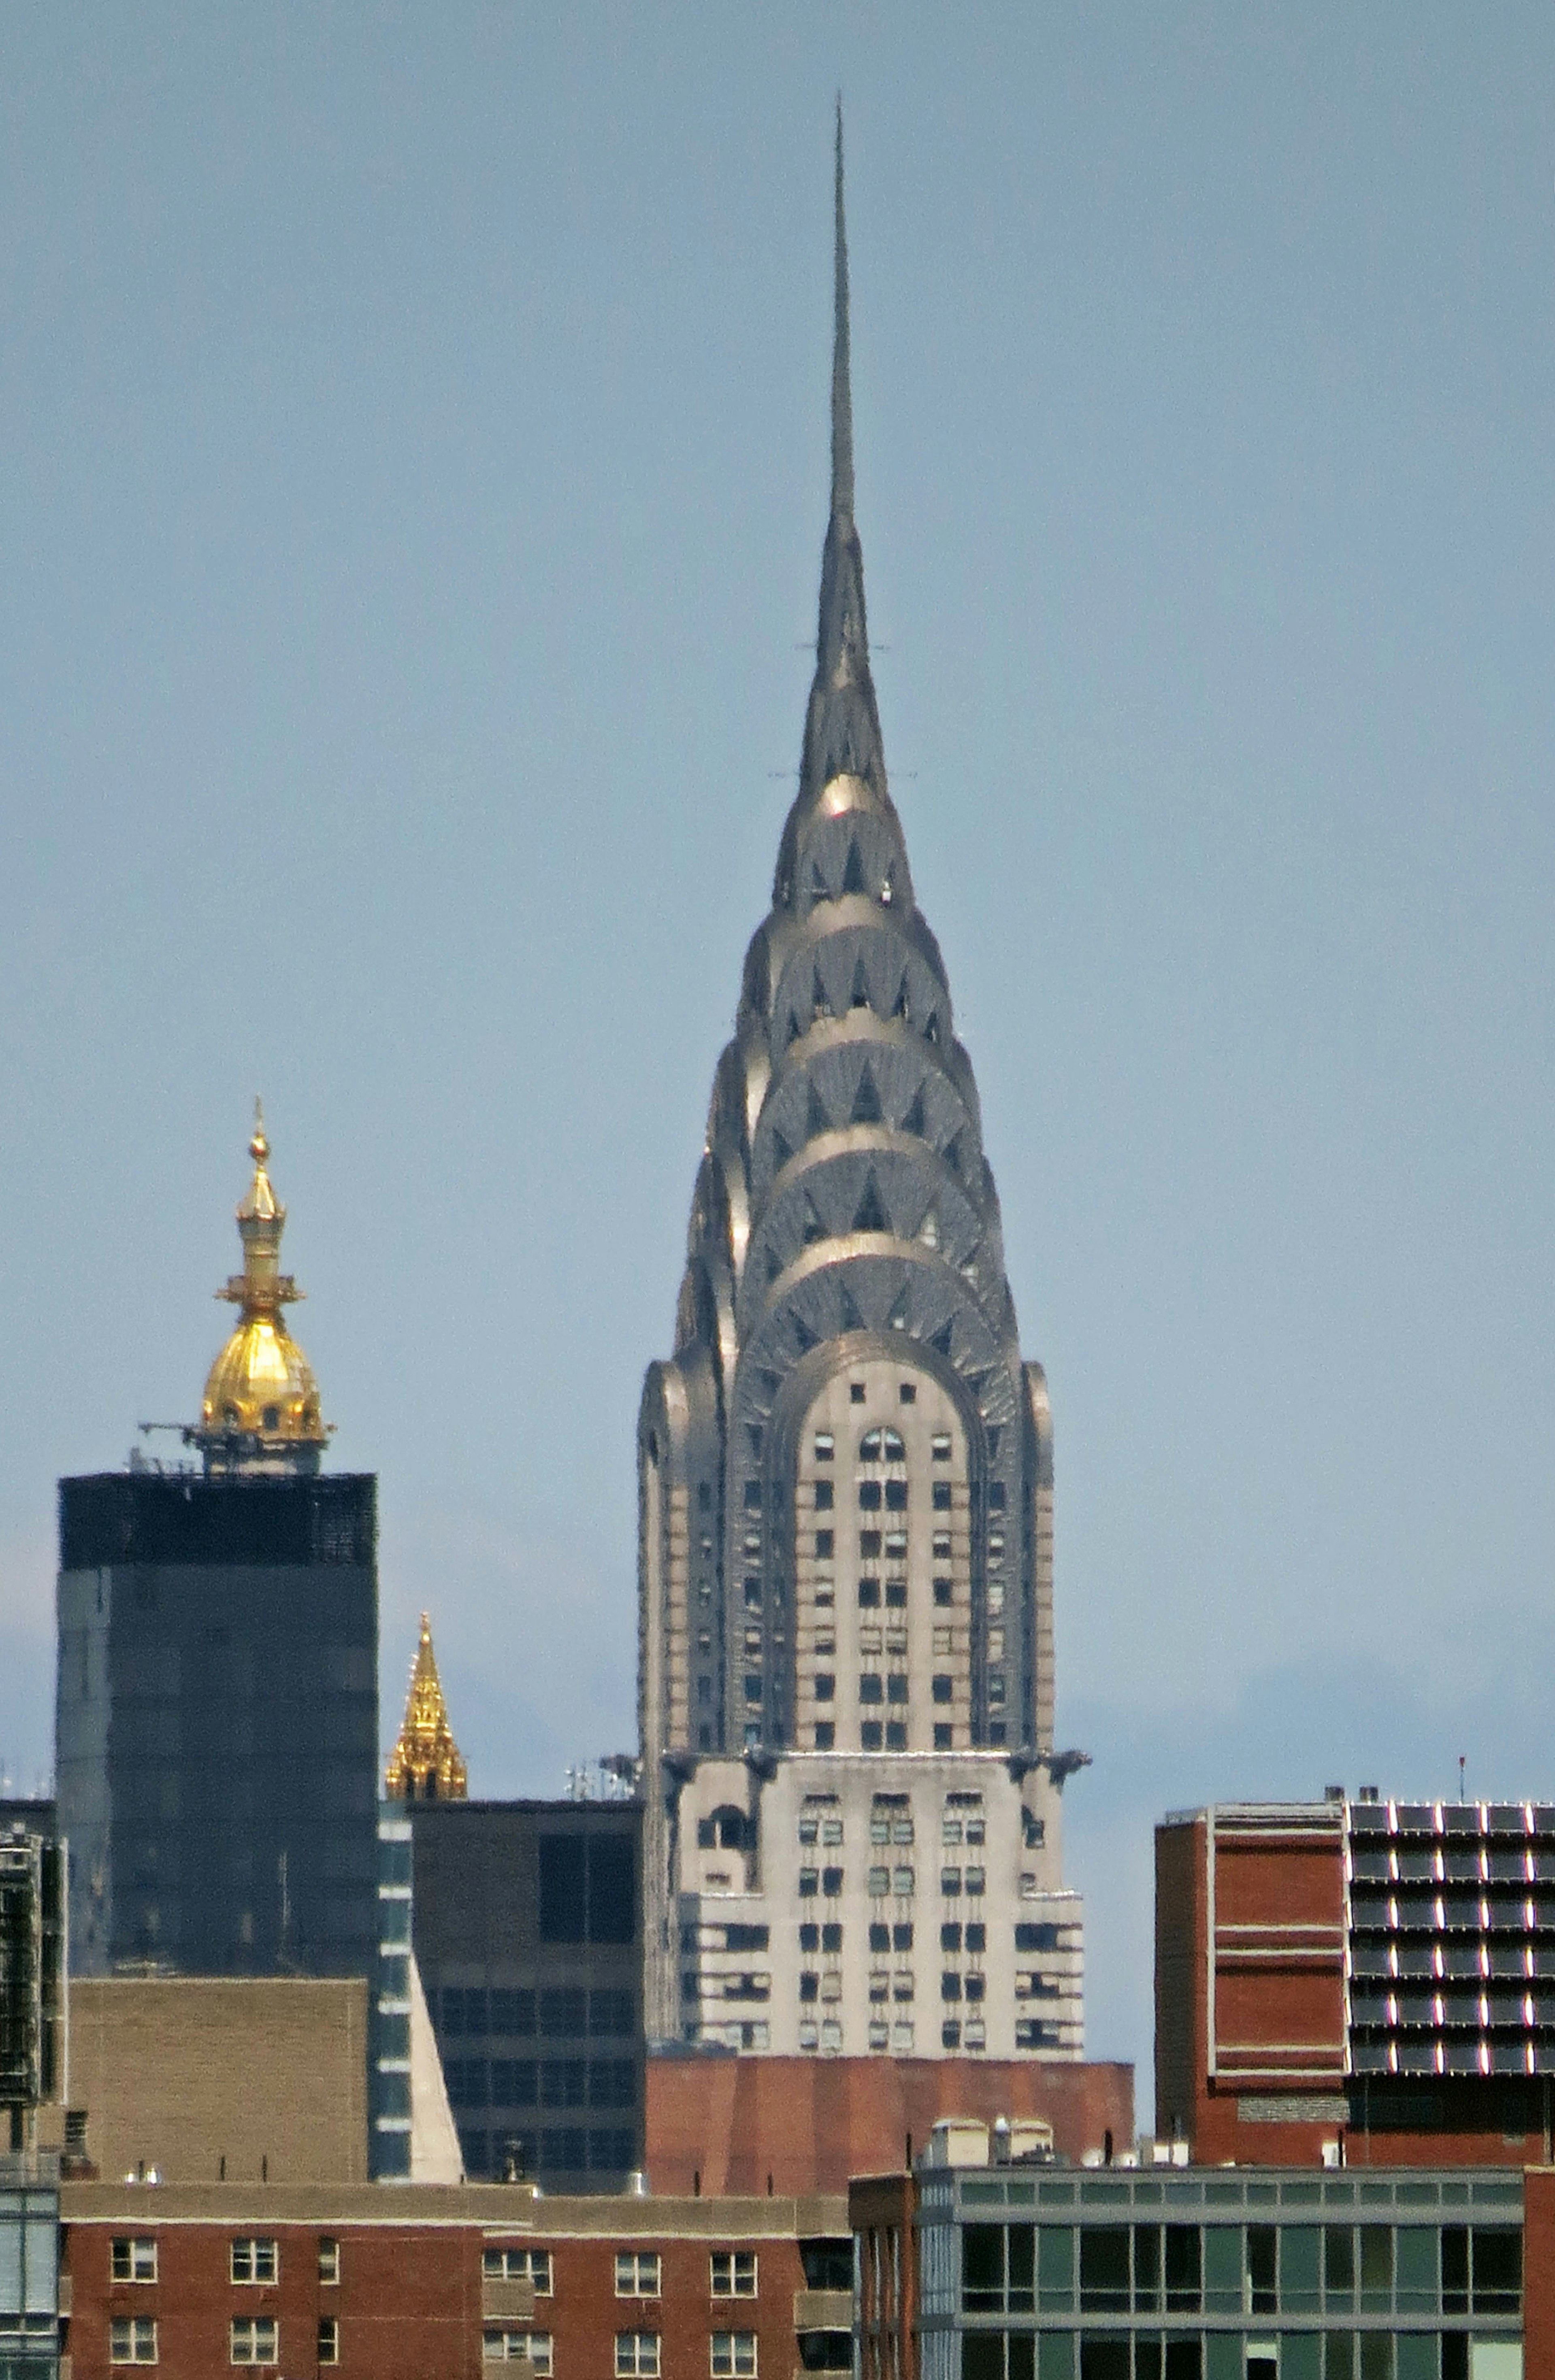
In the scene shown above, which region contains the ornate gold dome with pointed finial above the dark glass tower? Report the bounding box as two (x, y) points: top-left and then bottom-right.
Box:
(195, 1100), (329, 1468)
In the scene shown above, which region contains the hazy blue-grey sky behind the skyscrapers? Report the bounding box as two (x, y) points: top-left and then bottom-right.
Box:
(0, 5), (1555, 2116)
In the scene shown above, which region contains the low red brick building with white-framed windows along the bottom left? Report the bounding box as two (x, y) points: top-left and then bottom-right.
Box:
(62, 2182), (852, 2380)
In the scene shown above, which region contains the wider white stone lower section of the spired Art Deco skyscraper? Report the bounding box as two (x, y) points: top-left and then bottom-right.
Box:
(674, 1752), (1084, 2061)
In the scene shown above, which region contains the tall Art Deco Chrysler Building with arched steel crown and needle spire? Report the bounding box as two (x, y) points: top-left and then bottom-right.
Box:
(638, 121), (1084, 2059)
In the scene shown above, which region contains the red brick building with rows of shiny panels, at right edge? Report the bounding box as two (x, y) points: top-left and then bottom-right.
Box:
(1155, 1792), (1555, 2166)
